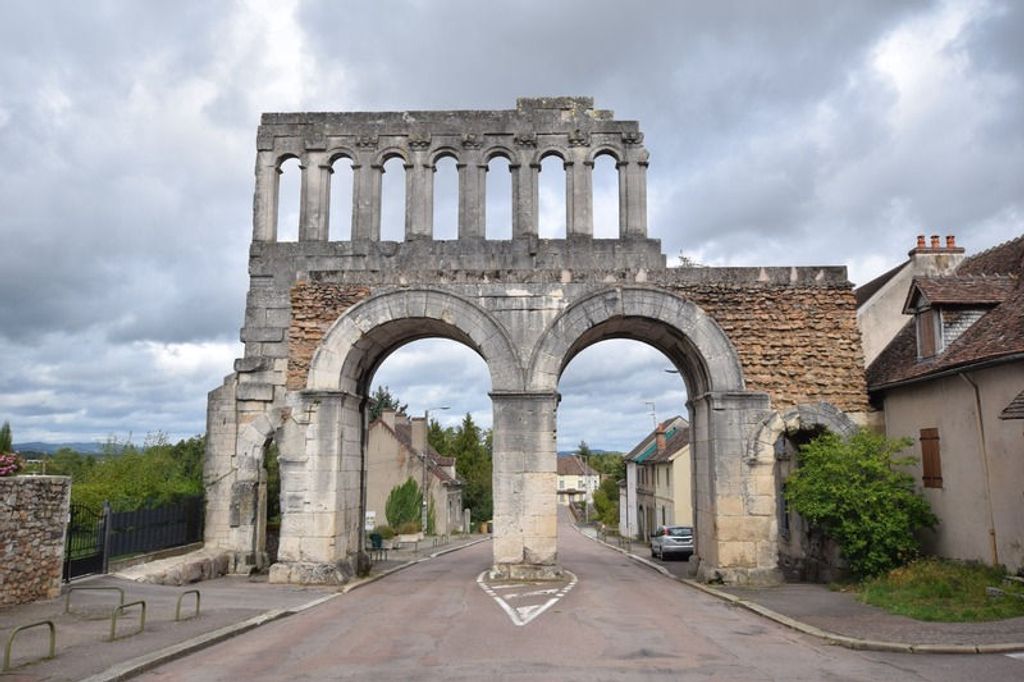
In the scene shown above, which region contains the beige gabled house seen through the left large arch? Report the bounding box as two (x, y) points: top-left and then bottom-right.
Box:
(366, 410), (463, 535)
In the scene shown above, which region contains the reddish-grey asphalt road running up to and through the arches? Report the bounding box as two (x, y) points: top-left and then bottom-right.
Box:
(141, 516), (1024, 682)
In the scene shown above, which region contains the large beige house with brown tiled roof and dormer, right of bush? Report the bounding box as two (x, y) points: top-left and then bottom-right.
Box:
(867, 236), (1024, 570)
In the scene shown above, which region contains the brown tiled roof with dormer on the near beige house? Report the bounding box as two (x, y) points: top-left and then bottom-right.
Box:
(867, 236), (1024, 391)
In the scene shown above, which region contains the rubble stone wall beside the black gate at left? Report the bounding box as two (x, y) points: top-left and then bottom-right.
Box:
(0, 476), (71, 606)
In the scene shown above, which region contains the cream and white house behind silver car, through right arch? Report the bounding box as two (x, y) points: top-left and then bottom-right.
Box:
(618, 416), (693, 539)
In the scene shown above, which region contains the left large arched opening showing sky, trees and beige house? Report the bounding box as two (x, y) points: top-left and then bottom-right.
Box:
(364, 338), (493, 539)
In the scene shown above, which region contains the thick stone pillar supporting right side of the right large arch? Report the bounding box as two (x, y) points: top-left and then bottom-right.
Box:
(689, 392), (781, 584)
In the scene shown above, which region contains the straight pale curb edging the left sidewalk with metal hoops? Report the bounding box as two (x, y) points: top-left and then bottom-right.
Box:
(82, 537), (490, 682)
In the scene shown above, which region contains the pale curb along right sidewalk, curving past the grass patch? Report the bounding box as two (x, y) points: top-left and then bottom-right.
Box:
(578, 528), (1024, 653)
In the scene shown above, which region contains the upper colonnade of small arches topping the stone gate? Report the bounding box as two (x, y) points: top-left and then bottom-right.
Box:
(253, 97), (648, 242)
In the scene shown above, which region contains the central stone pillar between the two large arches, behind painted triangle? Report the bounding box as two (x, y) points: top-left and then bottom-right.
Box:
(490, 392), (561, 580)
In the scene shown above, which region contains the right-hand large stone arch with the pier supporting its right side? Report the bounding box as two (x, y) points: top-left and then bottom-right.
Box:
(527, 286), (777, 582)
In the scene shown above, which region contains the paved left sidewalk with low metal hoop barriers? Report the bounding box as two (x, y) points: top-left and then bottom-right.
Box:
(0, 535), (489, 682)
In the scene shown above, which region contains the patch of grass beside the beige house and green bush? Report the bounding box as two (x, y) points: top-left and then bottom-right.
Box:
(859, 559), (1024, 623)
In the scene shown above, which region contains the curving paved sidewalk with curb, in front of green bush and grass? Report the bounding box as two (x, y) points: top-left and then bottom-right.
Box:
(585, 534), (1024, 653)
